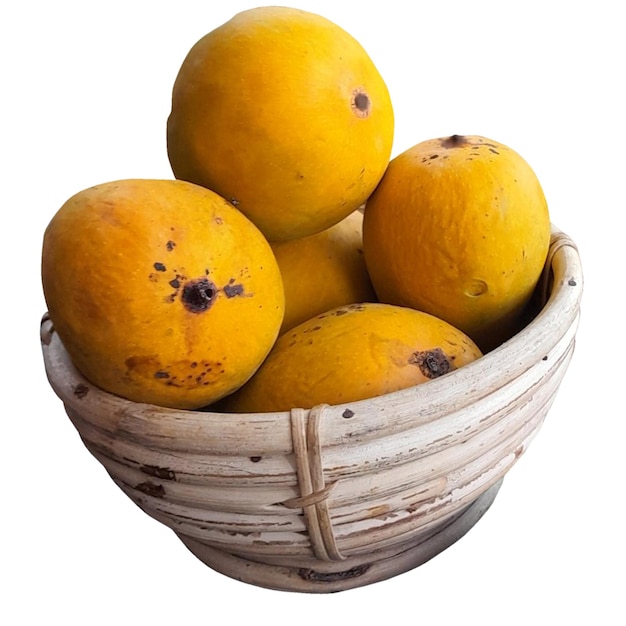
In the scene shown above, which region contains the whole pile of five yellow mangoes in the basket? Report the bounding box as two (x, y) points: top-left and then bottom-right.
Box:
(42, 7), (550, 412)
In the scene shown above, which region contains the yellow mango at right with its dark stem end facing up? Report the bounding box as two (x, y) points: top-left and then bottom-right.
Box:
(363, 135), (550, 351)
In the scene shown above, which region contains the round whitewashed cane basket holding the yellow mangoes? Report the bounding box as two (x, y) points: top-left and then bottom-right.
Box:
(41, 229), (583, 592)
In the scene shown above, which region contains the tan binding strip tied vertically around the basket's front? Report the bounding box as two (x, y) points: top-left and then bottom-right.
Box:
(283, 404), (345, 561)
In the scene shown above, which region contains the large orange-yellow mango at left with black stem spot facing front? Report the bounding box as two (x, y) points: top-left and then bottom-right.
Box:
(42, 179), (284, 409)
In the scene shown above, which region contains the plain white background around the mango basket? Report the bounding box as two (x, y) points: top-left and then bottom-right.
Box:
(0, 0), (626, 626)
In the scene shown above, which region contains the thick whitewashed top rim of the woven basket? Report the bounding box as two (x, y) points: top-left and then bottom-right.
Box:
(40, 225), (583, 454)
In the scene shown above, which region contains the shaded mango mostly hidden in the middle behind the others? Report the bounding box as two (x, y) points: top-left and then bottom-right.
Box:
(271, 210), (376, 333)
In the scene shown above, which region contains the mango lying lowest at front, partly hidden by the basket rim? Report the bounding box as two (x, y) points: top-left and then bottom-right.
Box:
(219, 303), (481, 413)
